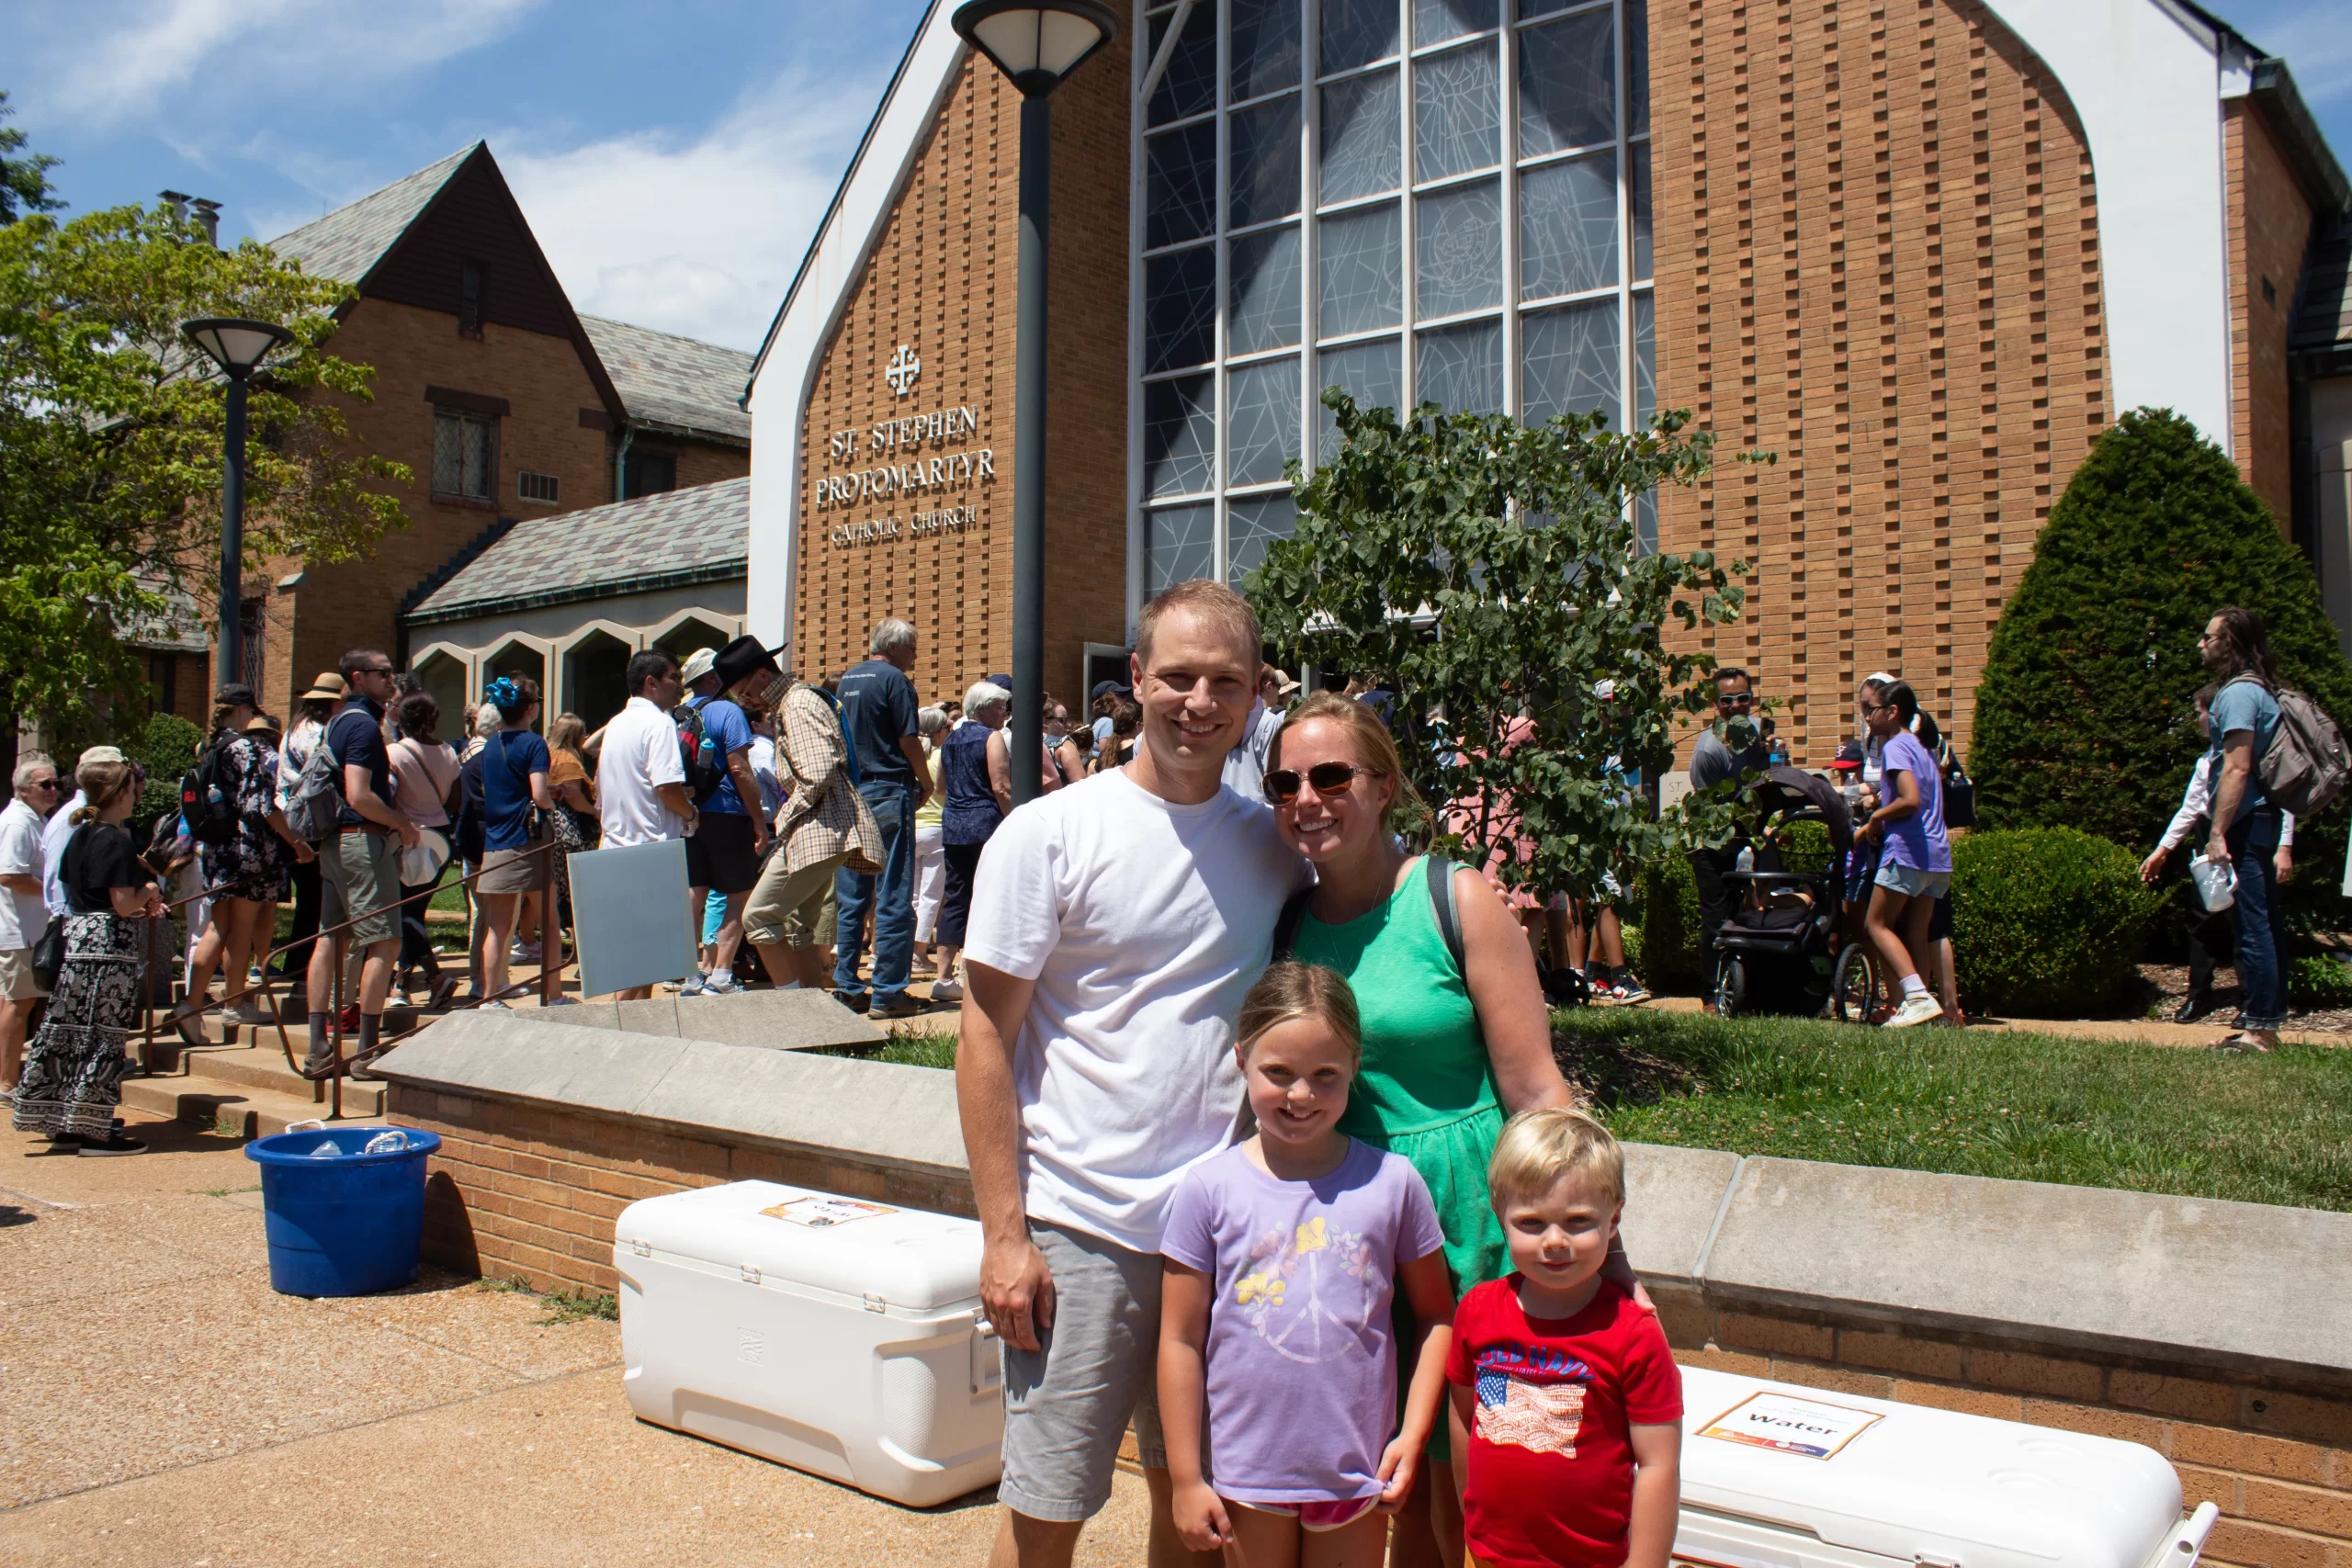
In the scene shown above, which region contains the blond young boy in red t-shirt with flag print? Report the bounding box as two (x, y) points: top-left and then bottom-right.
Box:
(1446, 1110), (1681, 1568)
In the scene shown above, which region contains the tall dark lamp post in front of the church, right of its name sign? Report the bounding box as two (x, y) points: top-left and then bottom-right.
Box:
(950, 0), (1120, 804)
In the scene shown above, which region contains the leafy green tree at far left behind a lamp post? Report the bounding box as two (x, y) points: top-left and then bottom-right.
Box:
(0, 207), (409, 727)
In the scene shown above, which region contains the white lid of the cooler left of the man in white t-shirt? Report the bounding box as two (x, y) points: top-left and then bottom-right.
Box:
(614, 1182), (981, 1312)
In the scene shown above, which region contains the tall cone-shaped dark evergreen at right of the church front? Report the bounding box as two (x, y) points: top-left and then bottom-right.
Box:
(1969, 409), (2352, 846)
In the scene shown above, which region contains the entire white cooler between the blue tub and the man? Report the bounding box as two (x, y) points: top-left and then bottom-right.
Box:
(612, 1182), (1004, 1506)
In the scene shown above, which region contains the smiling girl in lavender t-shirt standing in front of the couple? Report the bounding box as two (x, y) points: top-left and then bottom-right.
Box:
(1159, 962), (1453, 1568)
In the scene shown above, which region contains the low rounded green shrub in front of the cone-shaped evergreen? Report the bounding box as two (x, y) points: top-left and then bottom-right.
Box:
(1952, 828), (2166, 1018)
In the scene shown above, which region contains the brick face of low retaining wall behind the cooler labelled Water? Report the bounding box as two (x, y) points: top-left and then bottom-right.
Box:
(1660, 1293), (2352, 1568)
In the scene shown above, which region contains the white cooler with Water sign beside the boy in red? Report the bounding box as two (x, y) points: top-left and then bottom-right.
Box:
(1675, 1366), (2218, 1568)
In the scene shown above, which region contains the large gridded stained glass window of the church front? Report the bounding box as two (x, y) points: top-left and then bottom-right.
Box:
(1134, 0), (1656, 592)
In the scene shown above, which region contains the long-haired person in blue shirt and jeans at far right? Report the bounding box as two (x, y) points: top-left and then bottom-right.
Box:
(2197, 609), (2286, 1051)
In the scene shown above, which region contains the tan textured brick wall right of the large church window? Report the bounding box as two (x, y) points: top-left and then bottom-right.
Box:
(1651, 0), (2109, 764)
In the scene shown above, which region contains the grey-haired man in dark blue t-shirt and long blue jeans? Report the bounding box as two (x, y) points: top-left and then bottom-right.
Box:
(832, 616), (932, 1018)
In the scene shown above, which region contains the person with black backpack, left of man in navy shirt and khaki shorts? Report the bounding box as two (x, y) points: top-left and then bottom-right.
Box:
(167, 682), (315, 1046)
